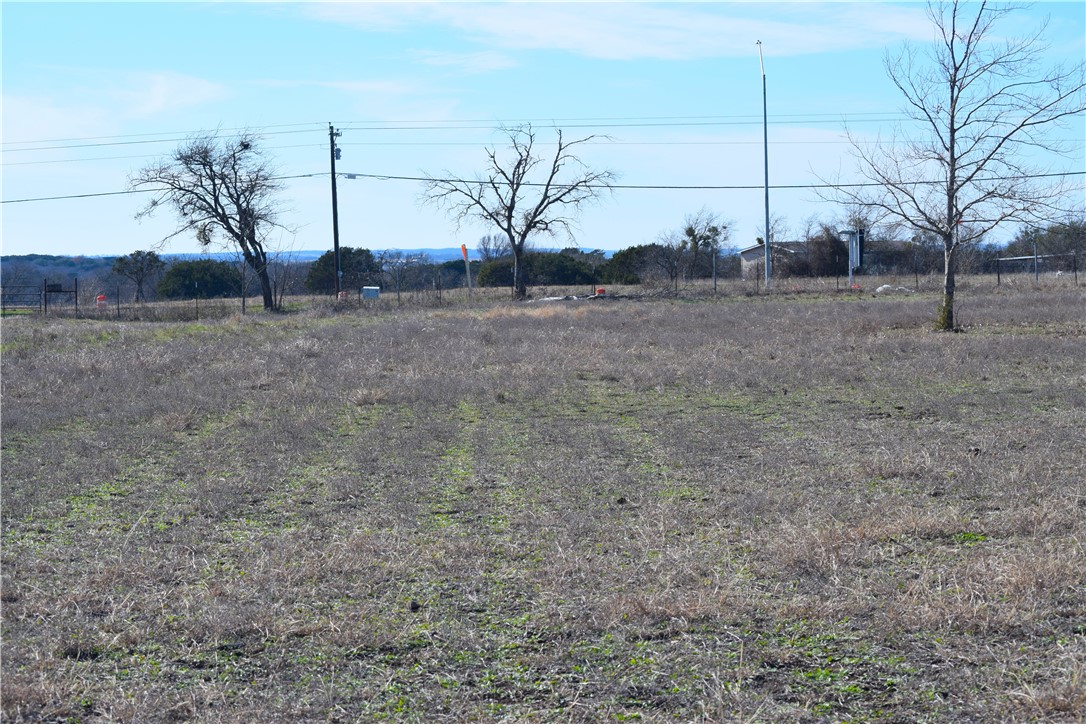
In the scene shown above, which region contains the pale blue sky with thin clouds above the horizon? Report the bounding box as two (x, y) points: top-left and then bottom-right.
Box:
(0, 1), (1086, 255)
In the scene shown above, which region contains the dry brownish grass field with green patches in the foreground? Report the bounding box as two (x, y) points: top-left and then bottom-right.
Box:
(0, 285), (1086, 722)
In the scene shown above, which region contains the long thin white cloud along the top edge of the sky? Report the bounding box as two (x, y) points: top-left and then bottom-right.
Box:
(308, 2), (930, 60)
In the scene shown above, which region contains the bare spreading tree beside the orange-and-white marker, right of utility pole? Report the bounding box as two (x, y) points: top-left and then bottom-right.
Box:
(424, 125), (615, 300)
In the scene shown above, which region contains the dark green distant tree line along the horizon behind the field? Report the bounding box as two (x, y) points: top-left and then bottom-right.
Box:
(2, 213), (1086, 302)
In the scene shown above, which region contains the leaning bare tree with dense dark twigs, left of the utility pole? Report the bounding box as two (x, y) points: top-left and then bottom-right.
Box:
(130, 132), (280, 309)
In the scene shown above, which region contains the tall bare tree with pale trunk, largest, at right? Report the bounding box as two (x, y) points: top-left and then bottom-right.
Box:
(836, 0), (1086, 330)
